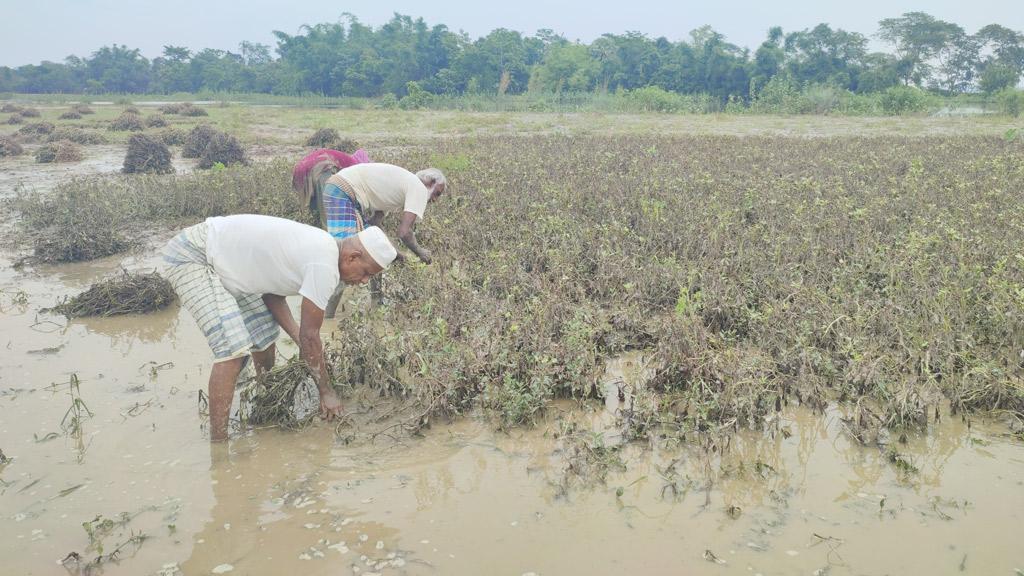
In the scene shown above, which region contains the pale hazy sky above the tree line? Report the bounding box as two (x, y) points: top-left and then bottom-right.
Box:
(0, 0), (1024, 66)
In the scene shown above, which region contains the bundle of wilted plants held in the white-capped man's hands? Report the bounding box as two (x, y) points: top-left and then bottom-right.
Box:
(240, 355), (318, 429)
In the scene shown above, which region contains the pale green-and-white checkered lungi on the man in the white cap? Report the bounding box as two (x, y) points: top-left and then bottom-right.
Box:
(164, 222), (281, 362)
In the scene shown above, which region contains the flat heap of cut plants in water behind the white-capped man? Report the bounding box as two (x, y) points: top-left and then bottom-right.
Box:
(47, 271), (175, 318)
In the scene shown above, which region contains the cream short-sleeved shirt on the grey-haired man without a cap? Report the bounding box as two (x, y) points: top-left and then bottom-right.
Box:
(328, 162), (430, 220)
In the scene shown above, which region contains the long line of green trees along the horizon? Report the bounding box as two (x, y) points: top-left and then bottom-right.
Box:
(0, 12), (1024, 100)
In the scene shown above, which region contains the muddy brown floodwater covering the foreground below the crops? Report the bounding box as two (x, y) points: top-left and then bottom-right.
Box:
(0, 253), (1024, 575)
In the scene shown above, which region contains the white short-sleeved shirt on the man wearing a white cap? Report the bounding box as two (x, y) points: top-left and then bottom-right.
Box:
(206, 214), (341, 310)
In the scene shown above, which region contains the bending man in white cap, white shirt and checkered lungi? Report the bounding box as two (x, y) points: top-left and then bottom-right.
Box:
(164, 214), (397, 442)
